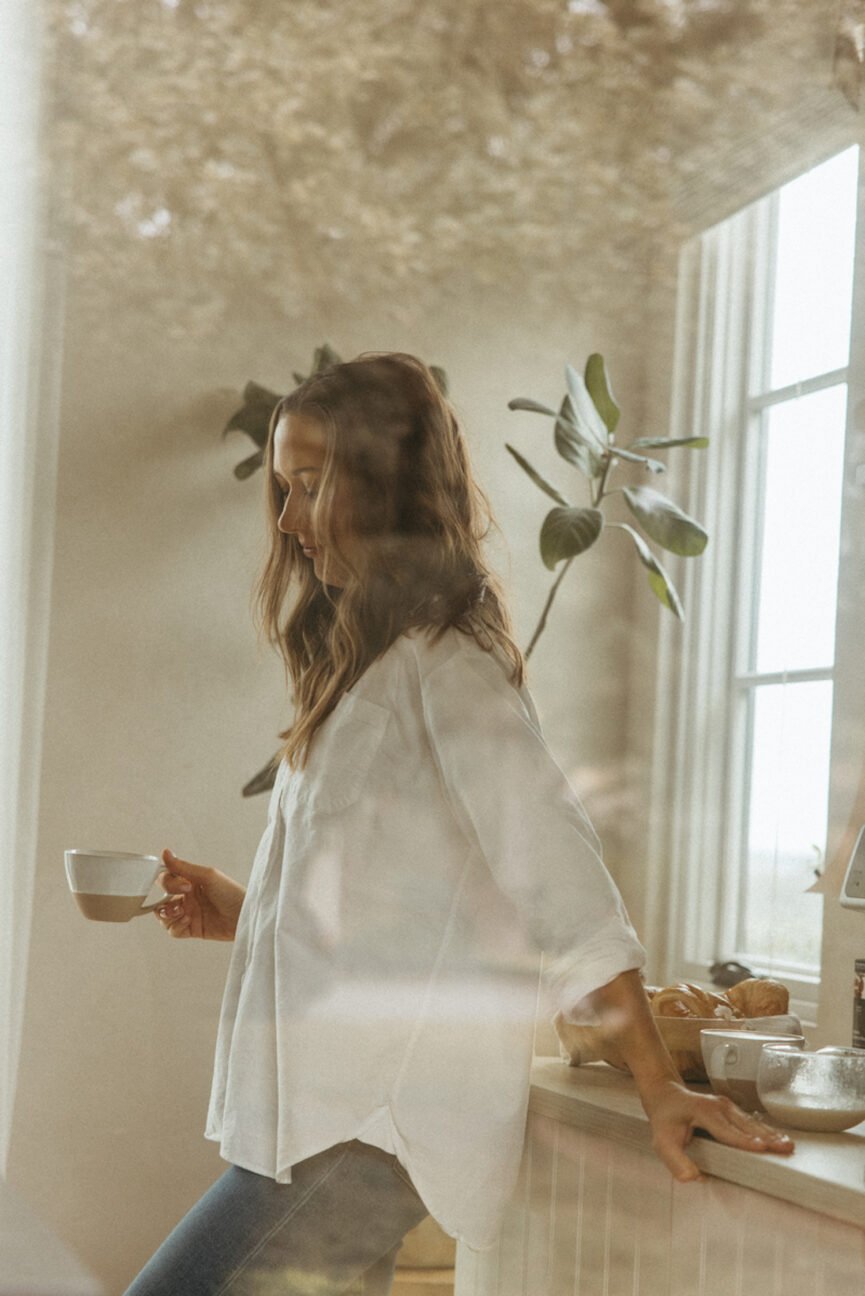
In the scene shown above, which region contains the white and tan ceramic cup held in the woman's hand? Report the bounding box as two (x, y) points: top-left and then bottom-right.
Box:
(64, 850), (171, 923)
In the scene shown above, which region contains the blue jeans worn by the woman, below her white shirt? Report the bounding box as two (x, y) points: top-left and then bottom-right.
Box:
(126, 1139), (427, 1296)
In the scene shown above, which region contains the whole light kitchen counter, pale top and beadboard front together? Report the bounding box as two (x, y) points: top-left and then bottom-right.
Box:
(455, 1058), (865, 1296)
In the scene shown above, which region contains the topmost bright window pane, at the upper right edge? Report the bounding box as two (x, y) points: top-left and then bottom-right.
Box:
(770, 148), (859, 389)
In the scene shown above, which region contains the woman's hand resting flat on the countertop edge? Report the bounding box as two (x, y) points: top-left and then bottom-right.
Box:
(639, 1078), (794, 1183)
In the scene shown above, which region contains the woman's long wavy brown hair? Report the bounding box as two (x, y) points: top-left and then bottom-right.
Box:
(255, 353), (524, 766)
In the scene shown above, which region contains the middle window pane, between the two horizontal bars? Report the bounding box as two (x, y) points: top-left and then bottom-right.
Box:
(753, 386), (847, 671)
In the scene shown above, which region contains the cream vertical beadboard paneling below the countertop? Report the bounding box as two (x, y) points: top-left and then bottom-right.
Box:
(455, 1113), (865, 1296)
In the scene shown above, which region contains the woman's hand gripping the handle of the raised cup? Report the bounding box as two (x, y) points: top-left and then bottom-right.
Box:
(156, 850), (246, 941)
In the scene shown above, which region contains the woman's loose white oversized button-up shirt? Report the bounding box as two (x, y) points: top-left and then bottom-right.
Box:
(206, 630), (645, 1248)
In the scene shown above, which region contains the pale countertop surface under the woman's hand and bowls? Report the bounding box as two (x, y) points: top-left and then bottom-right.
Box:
(529, 1058), (865, 1229)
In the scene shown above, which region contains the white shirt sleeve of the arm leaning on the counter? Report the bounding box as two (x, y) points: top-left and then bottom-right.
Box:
(421, 637), (646, 1023)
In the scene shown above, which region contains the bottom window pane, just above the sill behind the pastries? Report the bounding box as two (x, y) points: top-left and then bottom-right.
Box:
(741, 680), (833, 967)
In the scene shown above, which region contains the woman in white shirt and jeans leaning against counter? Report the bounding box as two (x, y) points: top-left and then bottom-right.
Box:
(130, 354), (791, 1296)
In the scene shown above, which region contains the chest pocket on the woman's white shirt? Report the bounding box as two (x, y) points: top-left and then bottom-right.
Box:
(297, 693), (389, 814)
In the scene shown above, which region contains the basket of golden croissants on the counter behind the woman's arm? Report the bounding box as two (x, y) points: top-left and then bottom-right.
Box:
(554, 977), (799, 1082)
